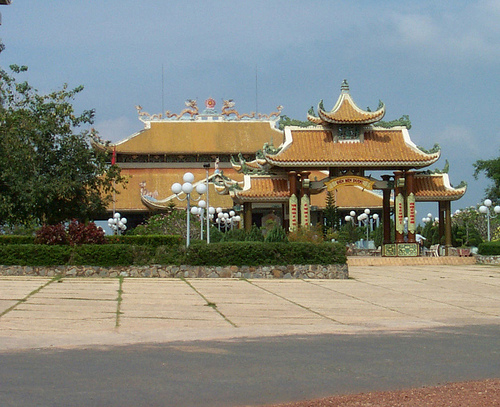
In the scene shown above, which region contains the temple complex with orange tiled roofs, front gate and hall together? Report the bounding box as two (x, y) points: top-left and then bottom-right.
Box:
(101, 81), (466, 256)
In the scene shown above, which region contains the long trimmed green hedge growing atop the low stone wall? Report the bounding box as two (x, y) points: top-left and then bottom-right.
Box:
(0, 242), (346, 267)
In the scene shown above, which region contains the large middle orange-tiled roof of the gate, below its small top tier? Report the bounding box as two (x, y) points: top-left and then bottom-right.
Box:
(266, 128), (440, 169)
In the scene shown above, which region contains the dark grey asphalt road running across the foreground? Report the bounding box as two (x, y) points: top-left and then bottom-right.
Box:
(0, 325), (500, 407)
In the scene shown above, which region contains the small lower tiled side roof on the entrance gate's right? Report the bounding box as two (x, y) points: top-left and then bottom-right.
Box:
(415, 174), (467, 202)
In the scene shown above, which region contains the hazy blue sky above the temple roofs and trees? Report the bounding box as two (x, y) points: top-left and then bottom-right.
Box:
(0, 0), (500, 215)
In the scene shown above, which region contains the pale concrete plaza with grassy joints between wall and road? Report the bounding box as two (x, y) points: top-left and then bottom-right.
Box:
(0, 265), (500, 351)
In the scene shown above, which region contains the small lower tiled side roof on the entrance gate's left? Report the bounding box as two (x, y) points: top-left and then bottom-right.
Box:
(236, 176), (290, 202)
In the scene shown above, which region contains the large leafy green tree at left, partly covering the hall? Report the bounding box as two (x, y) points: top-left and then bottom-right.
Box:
(0, 65), (123, 226)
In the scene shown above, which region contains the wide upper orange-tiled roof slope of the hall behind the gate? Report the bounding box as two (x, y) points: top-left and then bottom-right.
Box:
(108, 120), (283, 154)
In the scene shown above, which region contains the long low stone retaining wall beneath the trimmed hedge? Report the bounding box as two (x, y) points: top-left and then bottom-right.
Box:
(0, 264), (349, 279)
